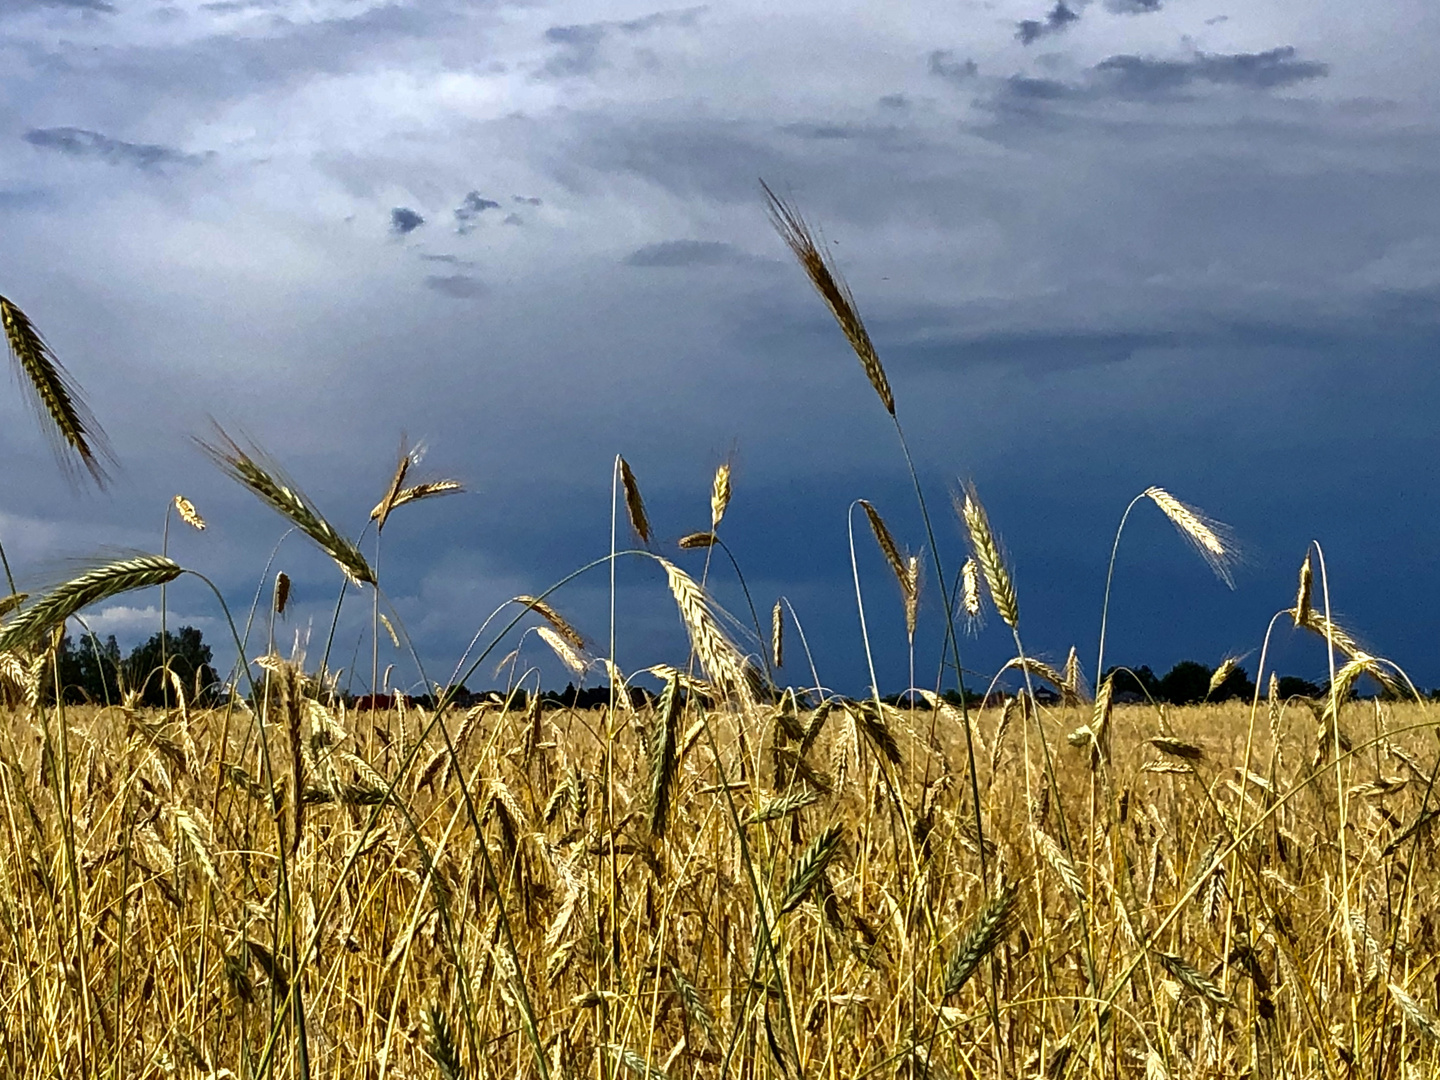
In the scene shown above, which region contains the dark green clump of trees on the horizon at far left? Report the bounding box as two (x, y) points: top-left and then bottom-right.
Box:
(42, 626), (219, 707)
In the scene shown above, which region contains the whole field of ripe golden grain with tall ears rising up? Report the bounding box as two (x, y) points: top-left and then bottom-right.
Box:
(0, 189), (1440, 1080)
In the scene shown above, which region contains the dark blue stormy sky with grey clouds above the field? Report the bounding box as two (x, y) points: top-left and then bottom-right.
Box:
(0, 0), (1440, 691)
